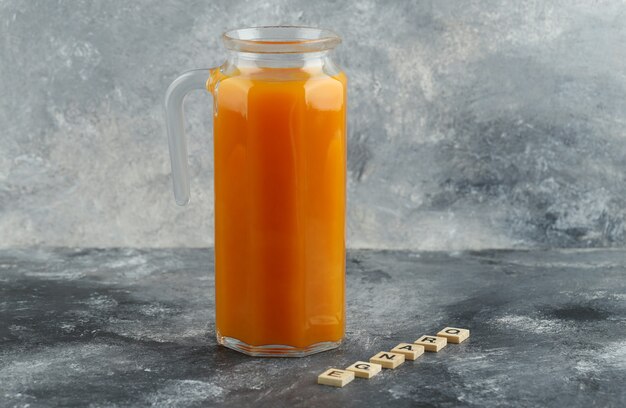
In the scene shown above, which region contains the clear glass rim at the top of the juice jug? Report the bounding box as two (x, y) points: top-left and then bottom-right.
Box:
(222, 25), (341, 54)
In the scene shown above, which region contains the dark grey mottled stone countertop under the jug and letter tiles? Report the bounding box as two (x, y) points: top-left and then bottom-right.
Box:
(0, 249), (626, 408)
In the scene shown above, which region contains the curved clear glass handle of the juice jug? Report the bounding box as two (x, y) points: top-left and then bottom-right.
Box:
(165, 69), (214, 205)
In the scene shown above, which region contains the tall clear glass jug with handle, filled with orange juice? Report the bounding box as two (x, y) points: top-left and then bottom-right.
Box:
(165, 26), (346, 357)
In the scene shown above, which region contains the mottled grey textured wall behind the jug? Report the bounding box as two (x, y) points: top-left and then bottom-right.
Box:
(0, 0), (626, 249)
